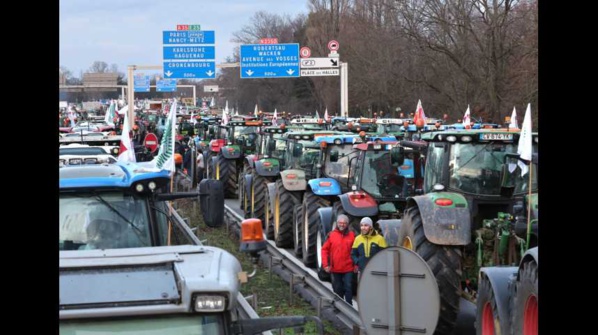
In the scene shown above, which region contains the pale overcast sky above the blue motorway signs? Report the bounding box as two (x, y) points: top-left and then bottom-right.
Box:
(59, 0), (308, 78)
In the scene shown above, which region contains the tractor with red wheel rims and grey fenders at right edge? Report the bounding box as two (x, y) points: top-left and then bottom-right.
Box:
(478, 154), (539, 335)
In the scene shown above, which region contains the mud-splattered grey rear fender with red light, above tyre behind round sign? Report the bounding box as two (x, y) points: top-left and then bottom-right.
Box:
(408, 192), (471, 245)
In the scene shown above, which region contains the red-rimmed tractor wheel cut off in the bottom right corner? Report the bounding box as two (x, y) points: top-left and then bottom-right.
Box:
(511, 261), (538, 335)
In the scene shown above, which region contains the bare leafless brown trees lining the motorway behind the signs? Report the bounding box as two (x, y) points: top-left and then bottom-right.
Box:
(63, 0), (538, 125)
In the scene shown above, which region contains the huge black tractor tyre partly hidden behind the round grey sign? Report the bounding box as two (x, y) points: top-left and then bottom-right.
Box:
(398, 207), (462, 335)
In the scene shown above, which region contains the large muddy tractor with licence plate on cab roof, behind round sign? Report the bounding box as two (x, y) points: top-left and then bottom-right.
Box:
(396, 129), (538, 334)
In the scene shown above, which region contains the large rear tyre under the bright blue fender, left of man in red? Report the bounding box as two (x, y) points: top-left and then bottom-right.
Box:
(301, 190), (328, 268)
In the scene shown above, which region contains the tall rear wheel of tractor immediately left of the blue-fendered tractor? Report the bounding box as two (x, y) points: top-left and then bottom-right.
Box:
(273, 179), (301, 248)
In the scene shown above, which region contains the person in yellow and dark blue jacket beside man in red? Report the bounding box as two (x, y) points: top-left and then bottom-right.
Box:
(351, 216), (388, 278)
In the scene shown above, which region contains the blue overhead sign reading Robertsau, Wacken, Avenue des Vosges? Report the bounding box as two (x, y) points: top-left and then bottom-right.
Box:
(240, 43), (300, 78)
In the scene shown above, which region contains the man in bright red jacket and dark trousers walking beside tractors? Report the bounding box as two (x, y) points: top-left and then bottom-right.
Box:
(322, 214), (357, 305)
